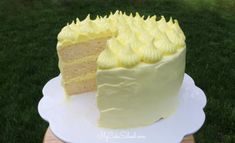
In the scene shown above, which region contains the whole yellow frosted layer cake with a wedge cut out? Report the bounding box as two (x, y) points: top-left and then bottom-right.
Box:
(57, 11), (186, 128)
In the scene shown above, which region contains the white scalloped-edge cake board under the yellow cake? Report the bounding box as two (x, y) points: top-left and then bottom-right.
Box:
(38, 74), (206, 143)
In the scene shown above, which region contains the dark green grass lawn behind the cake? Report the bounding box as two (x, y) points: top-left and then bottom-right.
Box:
(0, 0), (235, 143)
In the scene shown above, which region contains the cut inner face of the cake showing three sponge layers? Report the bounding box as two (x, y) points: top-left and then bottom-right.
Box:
(58, 38), (106, 95)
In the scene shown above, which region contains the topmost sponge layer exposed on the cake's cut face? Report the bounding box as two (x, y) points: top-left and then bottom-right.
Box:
(57, 38), (107, 63)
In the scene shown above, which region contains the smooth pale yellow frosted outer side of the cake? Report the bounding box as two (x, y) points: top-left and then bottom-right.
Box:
(97, 48), (186, 128)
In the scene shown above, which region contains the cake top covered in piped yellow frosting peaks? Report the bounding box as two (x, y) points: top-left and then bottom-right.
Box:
(57, 11), (186, 69)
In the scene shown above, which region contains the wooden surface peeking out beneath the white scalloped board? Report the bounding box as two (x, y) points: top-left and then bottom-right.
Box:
(43, 128), (195, 143)
